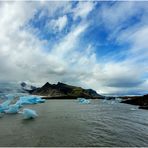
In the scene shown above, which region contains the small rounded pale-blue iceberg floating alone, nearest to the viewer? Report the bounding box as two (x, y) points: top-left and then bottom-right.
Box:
(22, 108), (38, 119)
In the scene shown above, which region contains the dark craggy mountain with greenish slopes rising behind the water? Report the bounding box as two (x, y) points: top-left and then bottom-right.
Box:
(30, 82), (103, 98)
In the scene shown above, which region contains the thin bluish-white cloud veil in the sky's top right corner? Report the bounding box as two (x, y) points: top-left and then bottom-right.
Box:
(98, 1), (146, 31)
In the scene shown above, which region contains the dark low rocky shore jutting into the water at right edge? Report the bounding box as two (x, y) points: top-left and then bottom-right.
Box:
(122, 94), (148, 109)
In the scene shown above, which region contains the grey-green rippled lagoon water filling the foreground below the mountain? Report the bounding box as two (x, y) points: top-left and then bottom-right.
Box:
(0, 100), (148, 147)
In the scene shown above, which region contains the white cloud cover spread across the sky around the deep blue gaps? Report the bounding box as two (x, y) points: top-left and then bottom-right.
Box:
(0, 2), (148, 93)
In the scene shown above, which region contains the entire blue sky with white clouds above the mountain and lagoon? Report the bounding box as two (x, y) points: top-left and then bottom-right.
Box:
(0, 0), (148, 94)
